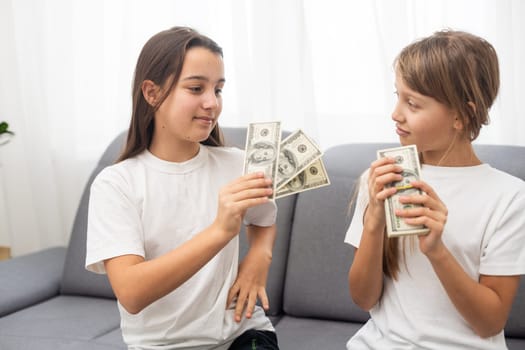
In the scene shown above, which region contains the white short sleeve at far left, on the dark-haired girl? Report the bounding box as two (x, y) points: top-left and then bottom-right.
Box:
(86, 167), (145, 273)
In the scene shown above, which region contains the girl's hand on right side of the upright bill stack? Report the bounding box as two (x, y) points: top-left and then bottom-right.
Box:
(396, 181), (448, 257)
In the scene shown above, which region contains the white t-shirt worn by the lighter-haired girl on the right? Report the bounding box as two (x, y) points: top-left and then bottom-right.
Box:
(345, 164), (525, 350)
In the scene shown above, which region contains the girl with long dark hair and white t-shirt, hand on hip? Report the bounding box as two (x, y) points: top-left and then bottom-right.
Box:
(86, 27), (278, 350)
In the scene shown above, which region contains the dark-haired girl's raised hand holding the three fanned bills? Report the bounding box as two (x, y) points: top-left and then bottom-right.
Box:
(213, 172), (272, 239)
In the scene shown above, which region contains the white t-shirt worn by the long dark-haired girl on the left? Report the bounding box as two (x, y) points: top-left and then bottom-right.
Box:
(86, 145), (276, 350)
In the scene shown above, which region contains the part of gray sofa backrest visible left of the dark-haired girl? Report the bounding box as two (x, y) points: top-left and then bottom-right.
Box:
(61, 132), (127, 298)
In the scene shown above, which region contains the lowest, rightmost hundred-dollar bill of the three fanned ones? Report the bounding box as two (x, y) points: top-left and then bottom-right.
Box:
(275, 158), (330, 198)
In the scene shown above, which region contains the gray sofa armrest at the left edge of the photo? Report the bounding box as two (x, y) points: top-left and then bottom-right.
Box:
(0, 247), (66, 317)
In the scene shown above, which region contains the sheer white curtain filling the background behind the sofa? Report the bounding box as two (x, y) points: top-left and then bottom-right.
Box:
(0, 0), (525, 255)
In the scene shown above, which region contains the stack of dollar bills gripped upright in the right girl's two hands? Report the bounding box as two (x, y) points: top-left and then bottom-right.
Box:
(377, 145), (429, 237)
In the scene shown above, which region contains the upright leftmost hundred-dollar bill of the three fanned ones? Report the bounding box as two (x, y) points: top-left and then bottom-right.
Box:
(244, 121), (281, 199)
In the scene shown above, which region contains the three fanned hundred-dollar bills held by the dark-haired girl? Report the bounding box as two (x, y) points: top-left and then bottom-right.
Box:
(244, 121), (330, 199)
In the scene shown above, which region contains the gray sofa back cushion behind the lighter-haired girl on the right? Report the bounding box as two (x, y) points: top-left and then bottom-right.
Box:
(283, 143), (525, 330)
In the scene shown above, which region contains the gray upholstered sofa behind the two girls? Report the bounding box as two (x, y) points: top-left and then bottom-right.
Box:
(0, 128), (525, 350)
